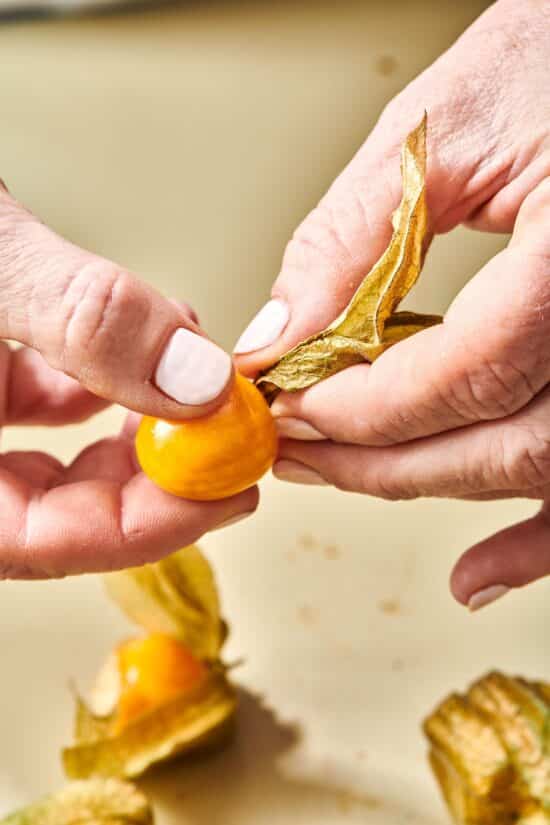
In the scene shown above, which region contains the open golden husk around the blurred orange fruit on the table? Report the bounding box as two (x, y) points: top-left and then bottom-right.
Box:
(62, 546), (237, 778)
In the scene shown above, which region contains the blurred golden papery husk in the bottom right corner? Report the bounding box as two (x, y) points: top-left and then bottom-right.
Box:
(430, 672), (550, 825)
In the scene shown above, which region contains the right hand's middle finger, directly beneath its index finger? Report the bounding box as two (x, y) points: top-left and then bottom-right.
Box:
(274, 389), (550, 500)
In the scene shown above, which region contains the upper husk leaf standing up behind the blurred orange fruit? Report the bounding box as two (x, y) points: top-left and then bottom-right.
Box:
(104, 545), (227, 660)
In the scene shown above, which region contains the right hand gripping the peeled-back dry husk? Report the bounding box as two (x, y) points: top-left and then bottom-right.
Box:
(236, 0), (550, 608)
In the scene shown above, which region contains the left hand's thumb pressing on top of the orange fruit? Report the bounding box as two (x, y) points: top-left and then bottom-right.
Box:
(0, 187), (232, 419)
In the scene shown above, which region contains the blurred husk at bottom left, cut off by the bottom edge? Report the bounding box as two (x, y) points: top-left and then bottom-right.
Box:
(0, 779), (153, 825)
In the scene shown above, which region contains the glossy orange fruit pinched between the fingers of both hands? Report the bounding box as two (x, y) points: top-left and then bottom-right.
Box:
(136, 374), (277, 501)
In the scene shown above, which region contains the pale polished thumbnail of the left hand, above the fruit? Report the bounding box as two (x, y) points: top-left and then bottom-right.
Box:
(155, 328), (232, 406)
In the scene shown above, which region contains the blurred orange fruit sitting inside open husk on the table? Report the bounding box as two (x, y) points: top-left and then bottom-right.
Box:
(116, 633), (207, 731)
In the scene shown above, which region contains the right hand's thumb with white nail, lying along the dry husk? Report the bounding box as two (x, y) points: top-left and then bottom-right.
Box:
(234, 121), (400, 375)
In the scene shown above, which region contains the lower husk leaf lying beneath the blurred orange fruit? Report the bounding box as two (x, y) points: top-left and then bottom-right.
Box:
(63, 667), (237, 779)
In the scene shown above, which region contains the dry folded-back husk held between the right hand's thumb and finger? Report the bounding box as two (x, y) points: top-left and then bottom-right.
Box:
(257, 115), (441, 402)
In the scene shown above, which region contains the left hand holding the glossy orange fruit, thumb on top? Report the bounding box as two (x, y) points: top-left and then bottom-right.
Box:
(0, 180), (257, 578)
